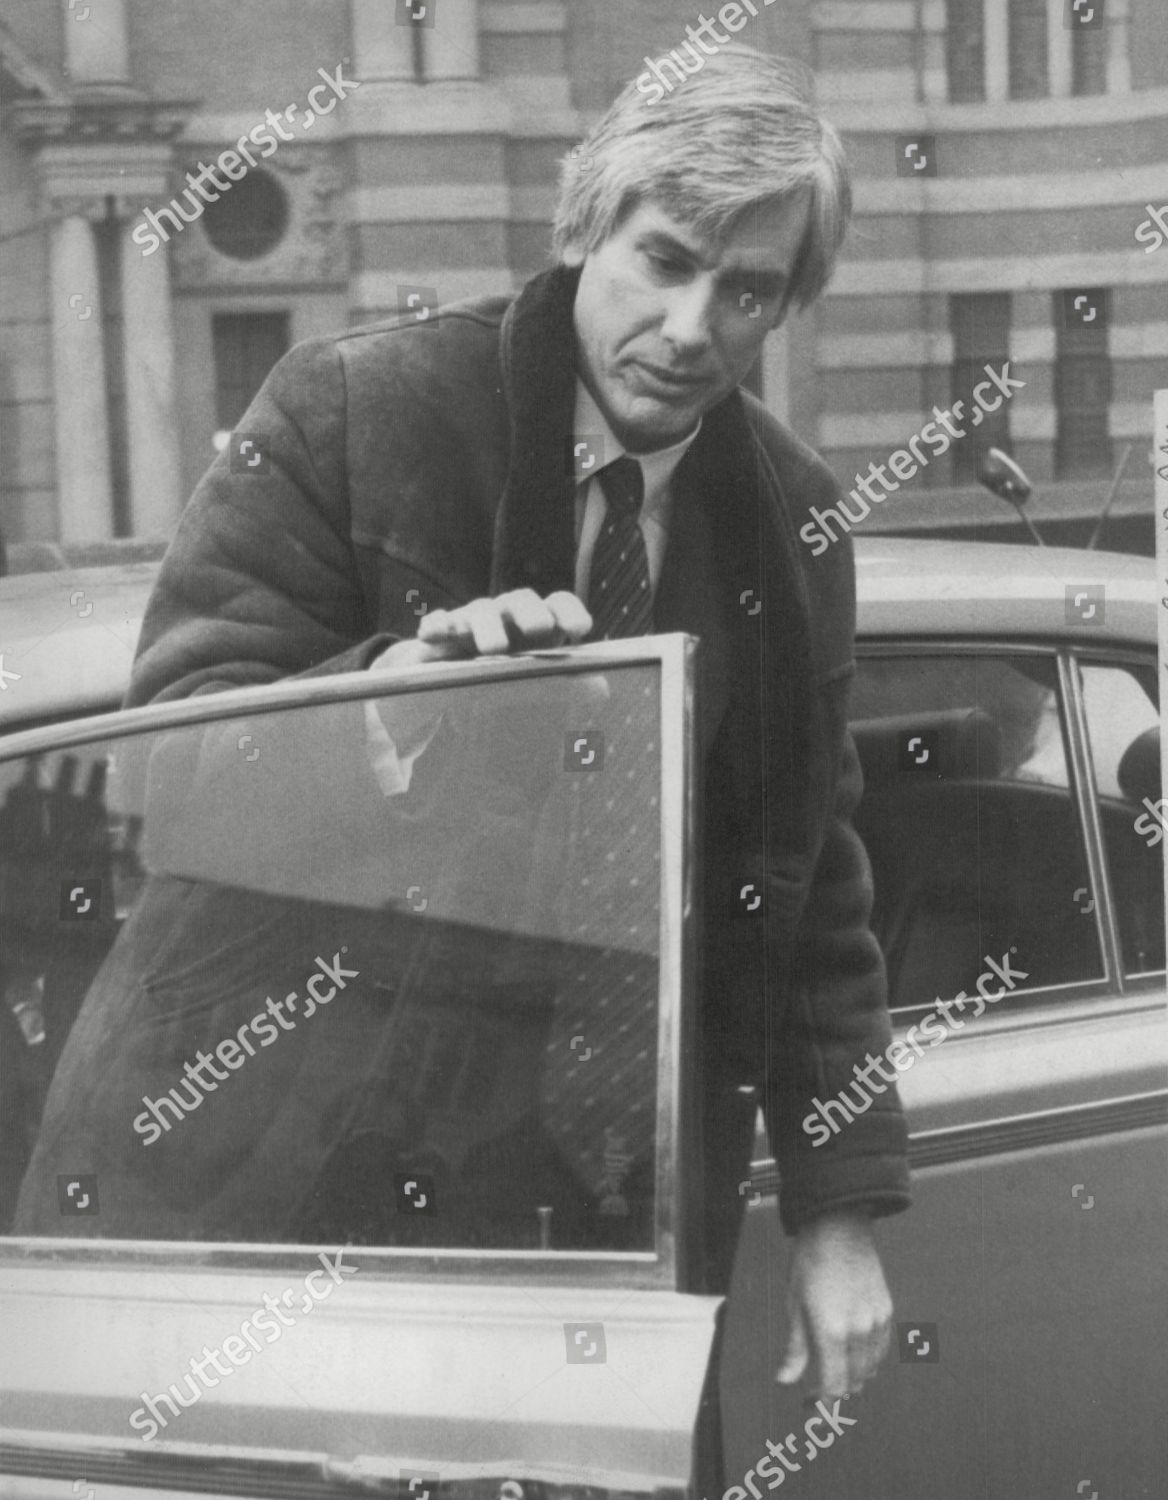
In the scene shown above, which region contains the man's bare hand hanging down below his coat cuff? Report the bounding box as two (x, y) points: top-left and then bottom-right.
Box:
(775, 1211), (892, 1401)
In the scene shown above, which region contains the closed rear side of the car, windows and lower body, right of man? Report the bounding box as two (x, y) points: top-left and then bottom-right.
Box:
(723, 641), (1168, 1500)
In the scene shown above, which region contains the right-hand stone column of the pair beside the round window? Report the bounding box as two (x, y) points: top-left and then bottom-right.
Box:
(120, 206), (183, 537)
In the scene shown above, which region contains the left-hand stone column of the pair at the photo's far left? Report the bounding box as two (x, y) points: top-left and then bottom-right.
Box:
(49, 212), (114, 542)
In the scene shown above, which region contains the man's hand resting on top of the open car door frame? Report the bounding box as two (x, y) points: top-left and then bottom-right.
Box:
(370, 588), (592, 671)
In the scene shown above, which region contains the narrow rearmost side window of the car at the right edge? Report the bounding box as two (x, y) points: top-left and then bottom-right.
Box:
(1080, 662), (1168, 975)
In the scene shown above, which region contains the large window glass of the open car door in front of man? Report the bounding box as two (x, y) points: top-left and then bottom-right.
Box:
(0, 666), (661, 1250)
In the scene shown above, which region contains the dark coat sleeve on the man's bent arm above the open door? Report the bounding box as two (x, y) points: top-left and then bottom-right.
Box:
(126, 341), (396, 707)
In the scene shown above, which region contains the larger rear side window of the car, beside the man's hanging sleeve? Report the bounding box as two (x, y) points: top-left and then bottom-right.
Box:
(852, 653), (1104, 1008)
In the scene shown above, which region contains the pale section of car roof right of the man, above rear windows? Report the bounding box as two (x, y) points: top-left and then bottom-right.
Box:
(855, 537), (1158, 647)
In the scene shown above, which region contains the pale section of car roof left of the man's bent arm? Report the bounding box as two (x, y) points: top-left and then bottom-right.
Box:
(0, 563), (157, 732)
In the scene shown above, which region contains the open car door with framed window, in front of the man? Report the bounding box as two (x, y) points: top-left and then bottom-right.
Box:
(0, 636), (718, 1500)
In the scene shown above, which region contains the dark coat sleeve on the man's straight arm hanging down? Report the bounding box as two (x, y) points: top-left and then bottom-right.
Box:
(749, 420), (910, 1232)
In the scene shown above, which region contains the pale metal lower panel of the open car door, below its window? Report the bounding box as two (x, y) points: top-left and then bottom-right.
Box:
(0, 1266), (718, 1494)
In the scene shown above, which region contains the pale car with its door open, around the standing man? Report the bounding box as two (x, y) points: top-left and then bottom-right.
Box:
(0, 539), (1168, 1500)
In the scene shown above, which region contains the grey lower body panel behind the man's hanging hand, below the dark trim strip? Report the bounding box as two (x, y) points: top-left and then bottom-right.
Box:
(725, 1128), (1168, 1500)
